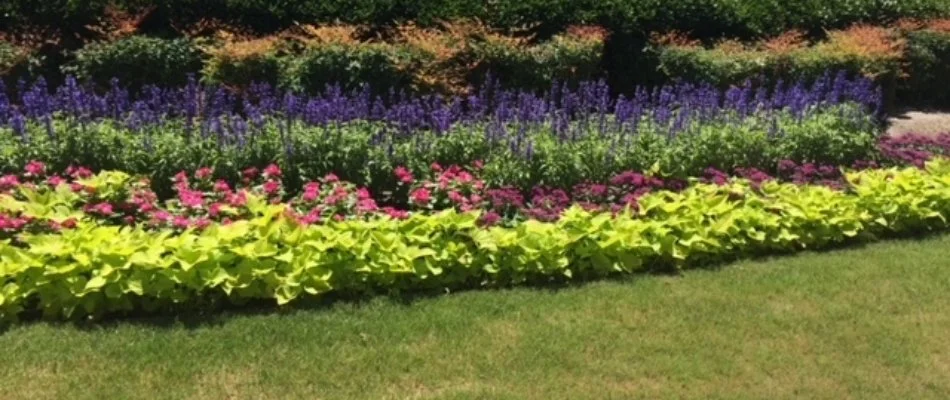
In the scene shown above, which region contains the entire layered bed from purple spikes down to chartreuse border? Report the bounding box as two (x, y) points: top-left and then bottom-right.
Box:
(0, 73), (950, 320)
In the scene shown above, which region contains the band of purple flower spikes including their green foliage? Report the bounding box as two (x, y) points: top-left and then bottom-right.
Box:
(0, 74), (880, 201)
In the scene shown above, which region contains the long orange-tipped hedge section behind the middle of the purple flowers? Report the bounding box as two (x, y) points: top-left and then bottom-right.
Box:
(203, 22), (606, 94)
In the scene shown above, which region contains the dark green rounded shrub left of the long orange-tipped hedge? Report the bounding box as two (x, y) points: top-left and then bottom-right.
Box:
(63, 36), (201, 88)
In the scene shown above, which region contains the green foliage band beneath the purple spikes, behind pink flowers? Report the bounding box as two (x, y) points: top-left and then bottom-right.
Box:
(0, 105), (877, 197)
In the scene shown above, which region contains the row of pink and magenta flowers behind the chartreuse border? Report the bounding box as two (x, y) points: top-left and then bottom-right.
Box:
(0, 152), (875, 238)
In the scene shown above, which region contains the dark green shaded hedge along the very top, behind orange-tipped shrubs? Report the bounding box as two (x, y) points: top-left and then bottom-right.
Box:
(0, 0), (950, 37)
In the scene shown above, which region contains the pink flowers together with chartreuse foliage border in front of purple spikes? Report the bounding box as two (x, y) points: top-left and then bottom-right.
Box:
(0, 159), (950, 319)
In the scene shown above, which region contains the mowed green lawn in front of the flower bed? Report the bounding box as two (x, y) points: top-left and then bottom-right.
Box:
(0, 236), (950, 399)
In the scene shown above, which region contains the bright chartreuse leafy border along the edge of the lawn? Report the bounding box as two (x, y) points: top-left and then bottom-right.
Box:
(0, 160), (950, 319)
